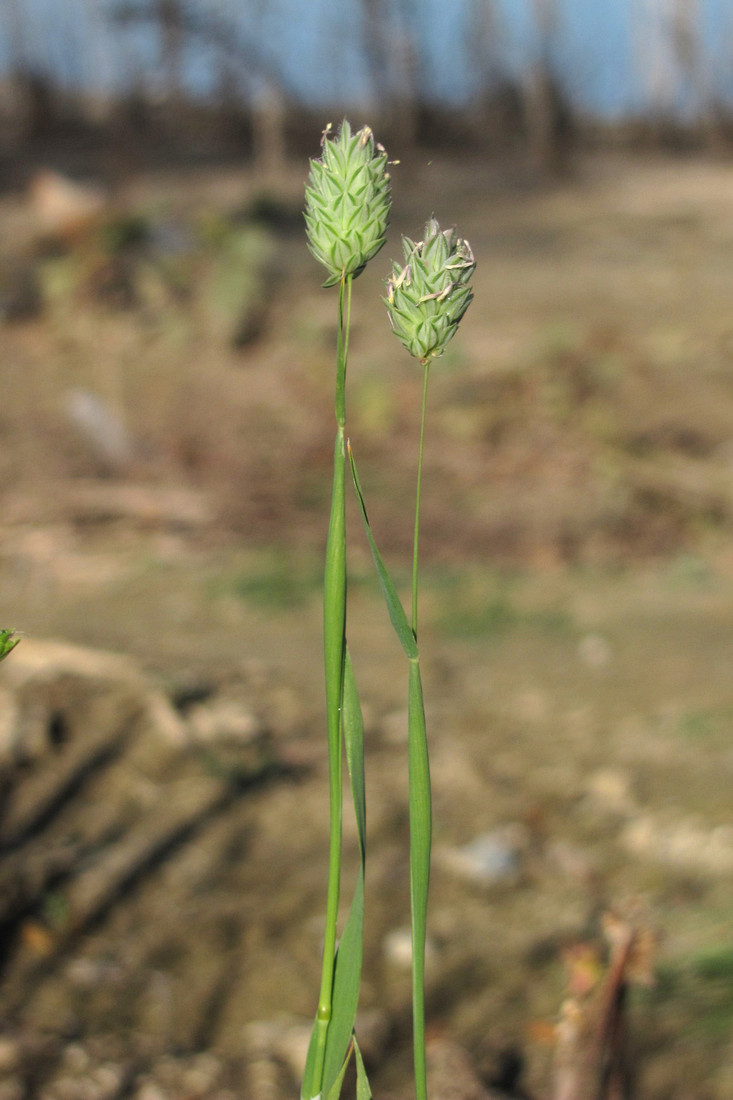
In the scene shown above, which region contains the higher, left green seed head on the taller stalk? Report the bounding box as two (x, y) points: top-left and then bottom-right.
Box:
(305, 119), (392, 286)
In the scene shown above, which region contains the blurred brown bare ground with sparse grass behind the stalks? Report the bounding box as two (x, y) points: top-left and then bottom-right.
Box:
(0, 148), (733, 1100)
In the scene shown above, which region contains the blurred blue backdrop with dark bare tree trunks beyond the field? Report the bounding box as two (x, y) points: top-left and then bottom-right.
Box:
(0, 0), (733, 167)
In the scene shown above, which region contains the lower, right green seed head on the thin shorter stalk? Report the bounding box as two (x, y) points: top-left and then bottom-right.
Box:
(384, 218), (475, 362)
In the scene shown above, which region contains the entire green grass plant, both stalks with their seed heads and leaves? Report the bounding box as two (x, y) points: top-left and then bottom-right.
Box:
(302, 120), (474, 1100)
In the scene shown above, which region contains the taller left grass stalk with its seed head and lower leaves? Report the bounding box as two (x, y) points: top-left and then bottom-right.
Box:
(302, 121), (391, 1100)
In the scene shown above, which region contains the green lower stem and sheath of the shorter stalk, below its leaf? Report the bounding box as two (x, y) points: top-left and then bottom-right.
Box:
(407, 660), (433, 1100)
